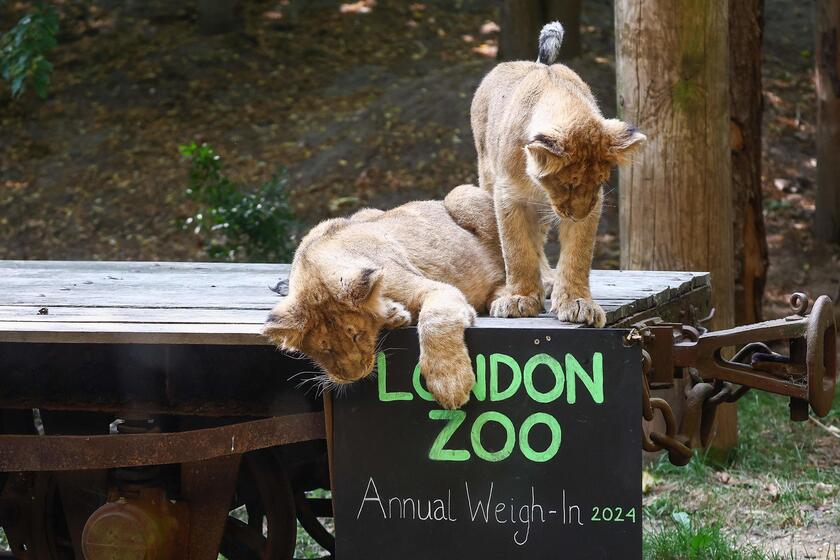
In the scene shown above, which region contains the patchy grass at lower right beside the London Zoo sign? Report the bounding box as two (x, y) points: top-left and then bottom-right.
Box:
(644, 391), (840, 559)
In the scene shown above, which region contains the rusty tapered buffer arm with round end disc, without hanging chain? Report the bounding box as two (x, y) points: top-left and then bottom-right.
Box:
(635, 294), (837, 420)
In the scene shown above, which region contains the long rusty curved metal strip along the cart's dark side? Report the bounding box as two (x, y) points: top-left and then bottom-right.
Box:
(0, 412), (326, 472)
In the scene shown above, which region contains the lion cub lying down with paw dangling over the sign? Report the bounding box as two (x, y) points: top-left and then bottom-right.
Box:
(263, 185), (505, 408)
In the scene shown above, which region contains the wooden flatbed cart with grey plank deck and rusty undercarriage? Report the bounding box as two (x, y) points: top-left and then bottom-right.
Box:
(0, 261), (709, 560)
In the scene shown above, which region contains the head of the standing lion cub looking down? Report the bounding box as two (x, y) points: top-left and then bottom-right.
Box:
(525, 115), (647, 220)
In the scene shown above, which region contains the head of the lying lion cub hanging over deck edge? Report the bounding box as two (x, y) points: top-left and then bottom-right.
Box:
(263, 268), (386, 384)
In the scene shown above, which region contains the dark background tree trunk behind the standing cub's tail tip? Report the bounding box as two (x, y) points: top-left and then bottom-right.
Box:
(498, 0), (582, 62)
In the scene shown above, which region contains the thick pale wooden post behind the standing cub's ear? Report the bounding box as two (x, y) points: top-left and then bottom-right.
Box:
(615, 0), (737, 450)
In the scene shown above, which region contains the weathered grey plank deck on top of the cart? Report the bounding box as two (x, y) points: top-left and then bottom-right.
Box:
(0, 261), (708, 344)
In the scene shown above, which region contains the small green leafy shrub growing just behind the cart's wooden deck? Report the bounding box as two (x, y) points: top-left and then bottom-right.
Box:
(179, 142), (296, 262)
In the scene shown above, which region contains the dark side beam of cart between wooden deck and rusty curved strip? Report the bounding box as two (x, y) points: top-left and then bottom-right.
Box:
(0, 343), (321, 416)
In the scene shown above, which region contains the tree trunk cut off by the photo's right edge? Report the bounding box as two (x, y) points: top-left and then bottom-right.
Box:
(815, 0), (840, 243)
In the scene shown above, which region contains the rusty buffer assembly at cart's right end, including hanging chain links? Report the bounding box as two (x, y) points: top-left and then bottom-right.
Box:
(640, 293), (837, 466)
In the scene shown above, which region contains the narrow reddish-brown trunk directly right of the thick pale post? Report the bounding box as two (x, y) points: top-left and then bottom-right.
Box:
(729, 0), (767, 325)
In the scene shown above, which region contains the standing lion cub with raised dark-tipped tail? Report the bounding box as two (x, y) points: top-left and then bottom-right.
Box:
(471, 22), (646, 327)
